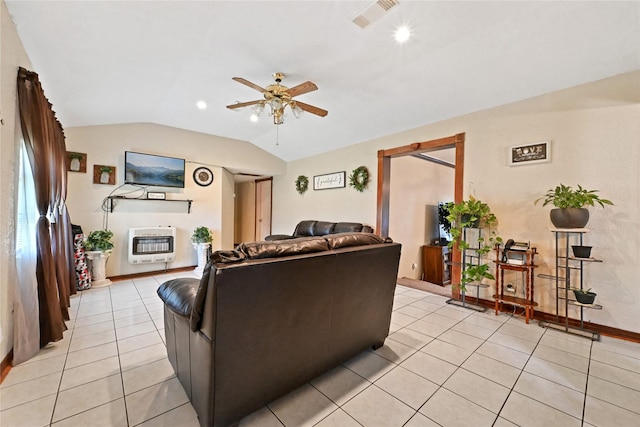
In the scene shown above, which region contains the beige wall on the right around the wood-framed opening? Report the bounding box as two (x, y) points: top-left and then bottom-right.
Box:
(273, 71), (640, 332)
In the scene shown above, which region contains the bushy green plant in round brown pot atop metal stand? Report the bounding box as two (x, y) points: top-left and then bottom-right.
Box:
(534, 184), (613, 228)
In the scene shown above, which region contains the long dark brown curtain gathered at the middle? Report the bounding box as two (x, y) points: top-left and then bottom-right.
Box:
(18, 68), (75, 347)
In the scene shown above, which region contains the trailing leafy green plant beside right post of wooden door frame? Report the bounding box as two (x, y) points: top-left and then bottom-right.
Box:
(445, 196), (502, 292)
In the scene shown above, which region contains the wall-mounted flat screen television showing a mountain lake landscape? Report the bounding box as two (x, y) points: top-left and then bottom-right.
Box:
(124, 151), (185, 188)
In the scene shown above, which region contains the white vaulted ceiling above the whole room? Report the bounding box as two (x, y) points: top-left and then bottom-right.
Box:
(6, 0), (640, 161)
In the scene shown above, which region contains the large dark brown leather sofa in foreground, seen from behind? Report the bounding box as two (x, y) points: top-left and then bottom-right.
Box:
(158, 233), (401, 427)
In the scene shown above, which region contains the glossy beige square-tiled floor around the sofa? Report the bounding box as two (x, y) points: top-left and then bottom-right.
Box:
(0, 275), (640, 427)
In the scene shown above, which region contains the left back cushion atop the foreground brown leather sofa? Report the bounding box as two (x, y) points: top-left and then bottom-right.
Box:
(236, 237), (329, 259)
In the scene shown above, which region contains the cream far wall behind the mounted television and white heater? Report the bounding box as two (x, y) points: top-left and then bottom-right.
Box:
(65, 123), (285, 276)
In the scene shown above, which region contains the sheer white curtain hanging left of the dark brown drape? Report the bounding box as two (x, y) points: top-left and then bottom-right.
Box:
(13, 141), (40, 365)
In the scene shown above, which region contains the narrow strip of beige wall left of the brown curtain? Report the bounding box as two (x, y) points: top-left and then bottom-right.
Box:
(0, 1), (31, 360)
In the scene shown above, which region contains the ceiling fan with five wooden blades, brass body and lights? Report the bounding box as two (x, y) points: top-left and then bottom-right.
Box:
(227, 73), (328, 125)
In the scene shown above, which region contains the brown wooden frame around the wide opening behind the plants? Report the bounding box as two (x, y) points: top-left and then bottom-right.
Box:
(376, 133), (465, 298)
